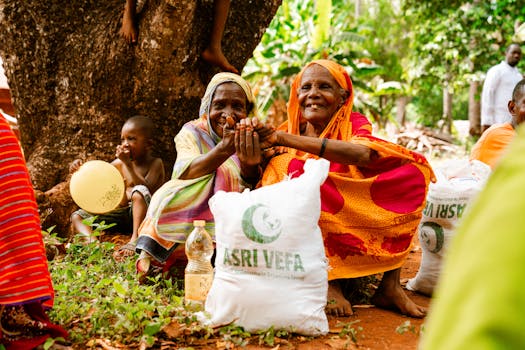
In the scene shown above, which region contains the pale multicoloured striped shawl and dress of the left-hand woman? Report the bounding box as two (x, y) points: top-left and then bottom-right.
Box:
(137, 73), (257, 262)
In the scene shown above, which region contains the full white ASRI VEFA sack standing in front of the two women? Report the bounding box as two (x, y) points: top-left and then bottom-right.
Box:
(205, 159), (329, 335)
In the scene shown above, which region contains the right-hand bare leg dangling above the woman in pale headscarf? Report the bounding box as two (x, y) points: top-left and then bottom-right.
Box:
(202, 0), (239, 73)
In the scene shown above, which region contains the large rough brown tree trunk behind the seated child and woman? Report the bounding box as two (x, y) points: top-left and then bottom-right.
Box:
(0, 0), (281, 235)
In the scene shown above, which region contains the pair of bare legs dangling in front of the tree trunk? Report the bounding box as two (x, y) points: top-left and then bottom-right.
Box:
(120, 0), (239, 74)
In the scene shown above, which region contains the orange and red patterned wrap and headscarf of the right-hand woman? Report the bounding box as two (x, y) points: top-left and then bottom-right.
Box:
(260, 60), (435, 280)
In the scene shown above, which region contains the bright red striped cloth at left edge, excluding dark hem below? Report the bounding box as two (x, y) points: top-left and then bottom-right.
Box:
(0, 117), (53, 305)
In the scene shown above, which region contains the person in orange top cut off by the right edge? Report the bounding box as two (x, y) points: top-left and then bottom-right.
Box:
(470, 79), (525, 170)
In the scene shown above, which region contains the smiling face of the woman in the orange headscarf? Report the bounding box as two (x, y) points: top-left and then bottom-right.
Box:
(297, 64), (348, 134)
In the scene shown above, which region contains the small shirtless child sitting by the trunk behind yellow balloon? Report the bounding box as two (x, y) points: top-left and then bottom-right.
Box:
(71, 115), (164, 260)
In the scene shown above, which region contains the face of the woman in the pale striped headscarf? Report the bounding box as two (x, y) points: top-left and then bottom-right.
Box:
(209, 82), (248, 138)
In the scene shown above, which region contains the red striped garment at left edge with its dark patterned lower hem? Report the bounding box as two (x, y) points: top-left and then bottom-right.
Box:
(0, 116), (67, 349)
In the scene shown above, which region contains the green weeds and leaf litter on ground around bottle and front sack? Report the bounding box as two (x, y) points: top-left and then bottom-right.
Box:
(43, 223), (356, 349)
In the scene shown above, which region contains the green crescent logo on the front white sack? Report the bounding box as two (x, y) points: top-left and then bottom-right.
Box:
(242, 204), (282, 243)
